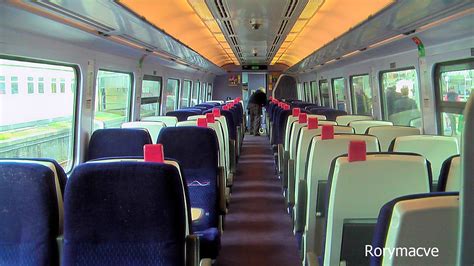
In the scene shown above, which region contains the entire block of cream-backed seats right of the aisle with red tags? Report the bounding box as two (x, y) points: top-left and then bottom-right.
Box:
(268, 100), (459, 265)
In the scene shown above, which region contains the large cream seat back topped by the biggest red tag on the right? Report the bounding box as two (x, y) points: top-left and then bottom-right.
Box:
(324, 153), (430, 265)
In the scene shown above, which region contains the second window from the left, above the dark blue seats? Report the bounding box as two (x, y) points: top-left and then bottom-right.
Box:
(94, 70), (132, 130)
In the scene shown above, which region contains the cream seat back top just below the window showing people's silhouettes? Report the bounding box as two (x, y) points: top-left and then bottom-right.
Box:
(366, 126), (420, 152)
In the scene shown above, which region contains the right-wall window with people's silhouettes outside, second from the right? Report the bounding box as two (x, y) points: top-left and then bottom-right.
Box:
(380, 69), (421, 126)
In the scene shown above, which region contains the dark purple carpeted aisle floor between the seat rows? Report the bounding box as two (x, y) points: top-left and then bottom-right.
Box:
(216, 135), (300, 266)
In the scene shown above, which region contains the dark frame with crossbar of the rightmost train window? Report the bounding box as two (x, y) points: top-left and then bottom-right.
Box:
(433, 57), (474, 135)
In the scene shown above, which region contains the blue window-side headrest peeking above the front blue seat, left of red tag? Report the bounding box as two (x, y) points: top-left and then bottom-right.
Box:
(86, 128), (153, 161)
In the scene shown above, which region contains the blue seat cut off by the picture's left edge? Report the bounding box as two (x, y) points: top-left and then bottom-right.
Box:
(0, 159), (66, 265)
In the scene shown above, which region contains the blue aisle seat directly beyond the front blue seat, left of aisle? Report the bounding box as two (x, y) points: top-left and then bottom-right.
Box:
(158, 126), (221, 258)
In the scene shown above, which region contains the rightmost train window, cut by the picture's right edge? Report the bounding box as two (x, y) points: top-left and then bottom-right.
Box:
(435, 59), (474, 137)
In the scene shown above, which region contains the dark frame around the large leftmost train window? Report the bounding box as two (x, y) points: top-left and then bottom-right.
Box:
(0, 55), (82, 172)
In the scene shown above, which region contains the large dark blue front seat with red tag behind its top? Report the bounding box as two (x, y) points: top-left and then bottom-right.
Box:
(62, 161), (189, 266)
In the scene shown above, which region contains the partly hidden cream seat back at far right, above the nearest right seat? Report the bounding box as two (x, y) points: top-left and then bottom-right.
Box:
(438, 155), (461, 192)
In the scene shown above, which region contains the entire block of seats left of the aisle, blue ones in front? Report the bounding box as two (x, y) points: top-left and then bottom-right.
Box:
(0, 99), (248, 265)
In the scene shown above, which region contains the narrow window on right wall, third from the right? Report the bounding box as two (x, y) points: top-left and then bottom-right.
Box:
(350, 75), (373, 116)
